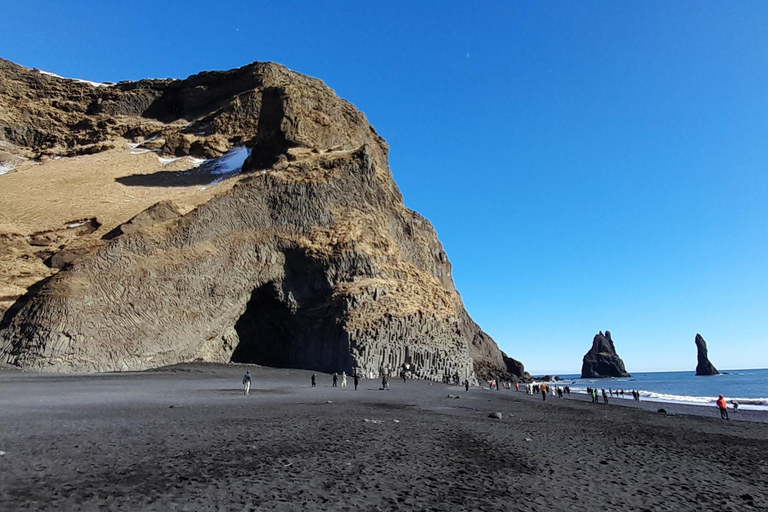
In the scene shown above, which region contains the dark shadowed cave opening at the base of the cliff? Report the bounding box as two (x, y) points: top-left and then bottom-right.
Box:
(232, 249), (352, 373)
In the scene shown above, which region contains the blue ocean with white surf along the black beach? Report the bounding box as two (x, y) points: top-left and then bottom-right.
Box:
(548, 369), (768, 410)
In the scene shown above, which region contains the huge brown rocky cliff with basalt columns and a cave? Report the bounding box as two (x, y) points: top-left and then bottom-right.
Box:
(0, 61), (527, 380)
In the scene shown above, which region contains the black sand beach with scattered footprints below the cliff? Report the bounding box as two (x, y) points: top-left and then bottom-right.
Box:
(0, 365), (768, 511)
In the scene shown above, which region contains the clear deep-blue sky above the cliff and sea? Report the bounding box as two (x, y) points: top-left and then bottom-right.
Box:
(6, 0), (768, 373)
